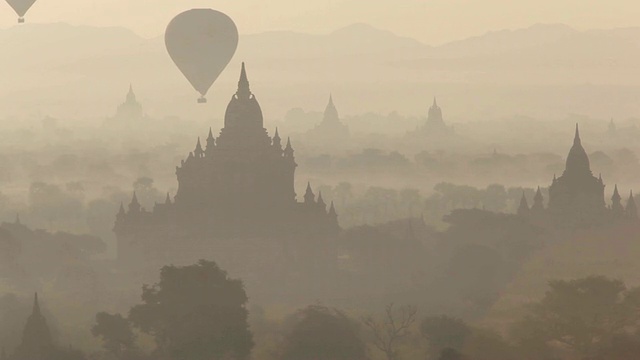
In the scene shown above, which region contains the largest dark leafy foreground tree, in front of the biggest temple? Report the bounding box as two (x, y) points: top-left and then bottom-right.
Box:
(129, 260), (253, 360)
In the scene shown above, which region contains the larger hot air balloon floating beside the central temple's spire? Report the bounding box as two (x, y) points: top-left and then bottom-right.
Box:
(164, 9), (238, 103)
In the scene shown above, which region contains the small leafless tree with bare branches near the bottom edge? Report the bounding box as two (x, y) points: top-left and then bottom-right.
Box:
(363, 303), (418, 360)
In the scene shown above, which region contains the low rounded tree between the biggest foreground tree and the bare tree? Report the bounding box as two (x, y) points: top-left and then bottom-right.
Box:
(281, 305), (366, 360)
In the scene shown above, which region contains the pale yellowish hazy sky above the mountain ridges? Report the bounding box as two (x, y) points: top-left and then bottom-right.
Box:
(0, 0), (640, 45)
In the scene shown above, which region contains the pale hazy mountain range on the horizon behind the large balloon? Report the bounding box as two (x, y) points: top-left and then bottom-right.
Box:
(0, 23), (640, 121)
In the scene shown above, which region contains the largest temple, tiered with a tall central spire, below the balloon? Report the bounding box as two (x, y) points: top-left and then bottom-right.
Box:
(114, 64), (339, 273)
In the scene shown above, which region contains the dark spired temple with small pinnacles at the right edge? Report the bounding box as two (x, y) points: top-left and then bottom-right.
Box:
(517, 124), (638, 227)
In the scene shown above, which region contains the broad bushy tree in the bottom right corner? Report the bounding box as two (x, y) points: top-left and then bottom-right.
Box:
(512, 276), (640, 357)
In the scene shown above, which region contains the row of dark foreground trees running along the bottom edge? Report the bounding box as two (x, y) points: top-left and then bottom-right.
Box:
(17, 261), (640, 360)
